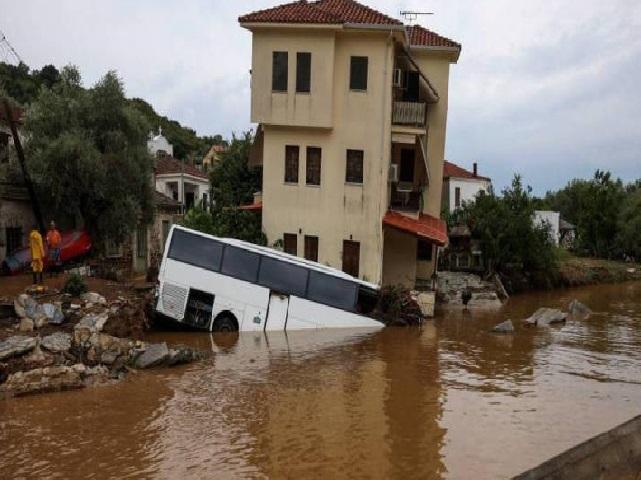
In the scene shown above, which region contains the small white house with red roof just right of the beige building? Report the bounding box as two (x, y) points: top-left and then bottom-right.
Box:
(443, 160), (492, 212)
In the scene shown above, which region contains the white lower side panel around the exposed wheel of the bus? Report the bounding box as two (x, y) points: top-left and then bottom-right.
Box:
(163, 258), (269, 331)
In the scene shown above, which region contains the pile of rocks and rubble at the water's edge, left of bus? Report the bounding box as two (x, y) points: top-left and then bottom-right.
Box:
(0, 292), (204, 398)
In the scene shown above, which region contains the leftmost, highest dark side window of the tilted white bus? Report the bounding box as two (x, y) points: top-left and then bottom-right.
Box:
(168, 229), (223, 272)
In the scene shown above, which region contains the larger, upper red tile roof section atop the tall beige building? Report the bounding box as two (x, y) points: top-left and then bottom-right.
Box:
(238, 0), (402, 25)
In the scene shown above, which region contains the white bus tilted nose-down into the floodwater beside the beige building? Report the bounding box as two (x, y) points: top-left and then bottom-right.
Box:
(156, 226), (383, 332)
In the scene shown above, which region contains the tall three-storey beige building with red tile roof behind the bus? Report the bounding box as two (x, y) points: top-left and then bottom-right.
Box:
(239, 0), (461, 286)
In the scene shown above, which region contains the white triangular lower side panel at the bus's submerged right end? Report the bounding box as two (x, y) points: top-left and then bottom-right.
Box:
(287, 296), (383, 330)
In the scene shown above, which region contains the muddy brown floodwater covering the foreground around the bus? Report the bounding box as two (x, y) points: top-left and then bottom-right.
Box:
(0, 283), (641, 480)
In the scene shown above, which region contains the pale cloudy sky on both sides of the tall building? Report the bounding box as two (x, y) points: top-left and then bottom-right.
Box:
(0, 0), (641, 193)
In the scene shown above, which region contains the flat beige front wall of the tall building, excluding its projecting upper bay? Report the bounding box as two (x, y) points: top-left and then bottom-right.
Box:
(263, 33), (393, 283)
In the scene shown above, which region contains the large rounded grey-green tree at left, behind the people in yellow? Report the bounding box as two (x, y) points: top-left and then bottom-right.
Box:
(26, 67), (153, 244)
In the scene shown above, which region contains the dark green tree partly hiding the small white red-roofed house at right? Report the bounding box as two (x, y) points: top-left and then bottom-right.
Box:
(450, 175), (556, 283)
